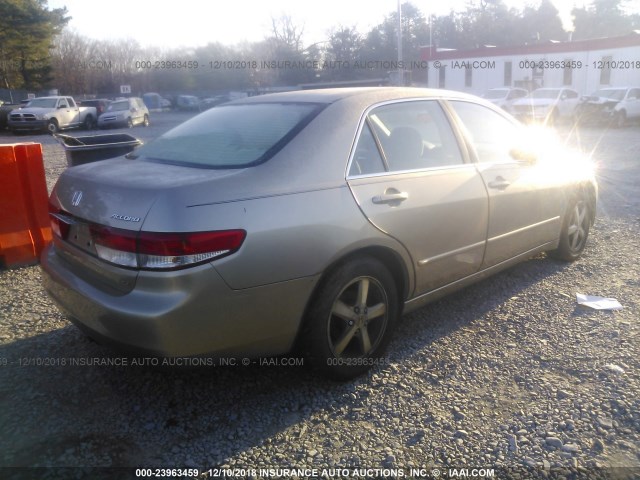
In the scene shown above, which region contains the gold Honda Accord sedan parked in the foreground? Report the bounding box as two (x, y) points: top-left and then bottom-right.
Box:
(42, 87), (597, 378)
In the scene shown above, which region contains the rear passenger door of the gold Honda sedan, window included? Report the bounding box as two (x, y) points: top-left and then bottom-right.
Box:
(348, 100), (488, 295)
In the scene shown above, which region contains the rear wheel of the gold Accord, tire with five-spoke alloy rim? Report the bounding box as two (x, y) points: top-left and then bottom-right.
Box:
(304, 257), (400, 380)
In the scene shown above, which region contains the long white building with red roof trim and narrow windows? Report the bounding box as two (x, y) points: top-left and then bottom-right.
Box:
(422, 31), (640, 95)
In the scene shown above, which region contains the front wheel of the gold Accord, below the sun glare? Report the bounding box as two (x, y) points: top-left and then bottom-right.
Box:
(549, 191), (592, 262)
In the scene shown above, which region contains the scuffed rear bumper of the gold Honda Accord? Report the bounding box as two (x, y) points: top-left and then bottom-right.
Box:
(41, 245), (317, 357)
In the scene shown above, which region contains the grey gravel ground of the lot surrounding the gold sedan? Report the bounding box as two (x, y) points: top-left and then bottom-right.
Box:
(0, 113), (640, 479)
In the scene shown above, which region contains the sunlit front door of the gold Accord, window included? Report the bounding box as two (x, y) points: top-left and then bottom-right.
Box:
(449, 101), (563, 267)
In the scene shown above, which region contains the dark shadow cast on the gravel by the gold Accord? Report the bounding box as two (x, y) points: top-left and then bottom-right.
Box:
(0, 256), (566, 469)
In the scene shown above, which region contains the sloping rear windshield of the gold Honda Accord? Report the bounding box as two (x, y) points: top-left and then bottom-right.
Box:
(135, 103), (322, 168)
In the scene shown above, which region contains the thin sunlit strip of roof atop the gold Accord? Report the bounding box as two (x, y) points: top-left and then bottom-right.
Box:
(232, 87), (477, 105)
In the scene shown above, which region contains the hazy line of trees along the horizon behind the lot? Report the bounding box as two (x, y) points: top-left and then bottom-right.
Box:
(0, 0), (640, 94)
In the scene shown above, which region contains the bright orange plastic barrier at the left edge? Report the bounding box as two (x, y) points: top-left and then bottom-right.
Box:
(0, 143), (51, 268)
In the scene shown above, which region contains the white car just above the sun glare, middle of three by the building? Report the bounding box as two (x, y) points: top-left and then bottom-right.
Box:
(512, 88), (580, 124)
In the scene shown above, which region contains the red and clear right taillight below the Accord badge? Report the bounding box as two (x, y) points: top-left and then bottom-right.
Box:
(90, 226), (246, 270)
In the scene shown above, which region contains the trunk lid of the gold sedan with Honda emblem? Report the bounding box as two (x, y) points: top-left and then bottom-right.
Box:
(51, 158), (245, 293)
